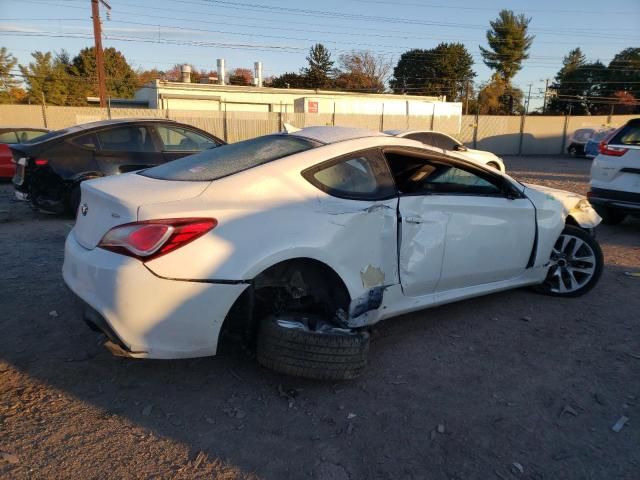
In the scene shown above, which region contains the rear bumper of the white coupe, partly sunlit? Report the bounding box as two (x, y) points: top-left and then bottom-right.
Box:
(62, 231), (247, 359)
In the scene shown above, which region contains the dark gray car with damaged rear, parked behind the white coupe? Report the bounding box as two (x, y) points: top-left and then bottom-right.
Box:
(11, 119), (224, 214)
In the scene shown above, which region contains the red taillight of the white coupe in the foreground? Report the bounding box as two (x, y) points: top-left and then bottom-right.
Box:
(98, 218), (218, 261)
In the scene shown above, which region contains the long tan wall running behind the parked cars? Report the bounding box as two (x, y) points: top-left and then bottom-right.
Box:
(0, 104), (635, 155)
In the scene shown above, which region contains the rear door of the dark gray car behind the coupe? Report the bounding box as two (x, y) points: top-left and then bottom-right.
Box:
(95, 125), (165, 175)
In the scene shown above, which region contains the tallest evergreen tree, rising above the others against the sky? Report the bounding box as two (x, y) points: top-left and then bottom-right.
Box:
(480, 10), (534, 83)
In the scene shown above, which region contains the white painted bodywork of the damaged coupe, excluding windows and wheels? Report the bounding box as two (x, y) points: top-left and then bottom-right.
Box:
(63, 127), (600, 358)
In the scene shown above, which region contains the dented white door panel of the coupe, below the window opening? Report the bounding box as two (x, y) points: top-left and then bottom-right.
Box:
(400, 195), (536, 297)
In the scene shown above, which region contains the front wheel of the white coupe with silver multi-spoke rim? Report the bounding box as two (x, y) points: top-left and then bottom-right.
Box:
(537, 225), (604, 297)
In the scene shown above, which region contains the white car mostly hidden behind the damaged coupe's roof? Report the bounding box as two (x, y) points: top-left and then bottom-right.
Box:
(385, 130), (506, 173)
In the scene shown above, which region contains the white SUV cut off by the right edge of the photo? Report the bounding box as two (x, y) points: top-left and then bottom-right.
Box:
(587, 118), (640, 225)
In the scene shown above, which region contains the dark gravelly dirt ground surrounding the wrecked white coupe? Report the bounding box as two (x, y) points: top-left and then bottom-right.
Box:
(0, 157), (640, 480)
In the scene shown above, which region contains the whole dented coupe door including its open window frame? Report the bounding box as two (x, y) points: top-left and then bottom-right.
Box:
(385, 151), (536, 297)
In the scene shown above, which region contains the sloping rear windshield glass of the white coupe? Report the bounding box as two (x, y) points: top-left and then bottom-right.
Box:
(140, 135), (319, 181)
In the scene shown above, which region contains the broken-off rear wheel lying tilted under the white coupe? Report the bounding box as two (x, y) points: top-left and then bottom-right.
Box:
(257, 314), (369, 380)
